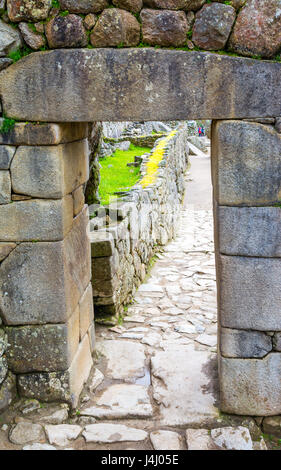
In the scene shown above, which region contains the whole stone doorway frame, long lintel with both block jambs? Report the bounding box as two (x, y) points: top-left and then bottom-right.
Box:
(0, 1), (281, 416)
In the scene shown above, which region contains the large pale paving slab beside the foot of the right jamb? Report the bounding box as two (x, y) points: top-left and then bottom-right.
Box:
(151, 345), (219, 427)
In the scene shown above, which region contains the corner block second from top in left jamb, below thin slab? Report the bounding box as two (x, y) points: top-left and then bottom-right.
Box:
(11, 140), (89, 199)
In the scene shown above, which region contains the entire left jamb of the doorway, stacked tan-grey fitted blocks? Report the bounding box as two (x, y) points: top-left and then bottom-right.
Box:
(0, 123), (94, 412)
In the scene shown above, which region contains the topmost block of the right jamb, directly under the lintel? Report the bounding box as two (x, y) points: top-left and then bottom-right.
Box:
(212, 121), (281, 206)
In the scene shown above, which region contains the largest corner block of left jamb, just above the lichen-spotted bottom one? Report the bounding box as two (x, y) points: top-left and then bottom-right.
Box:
(0, 206), (91, 325)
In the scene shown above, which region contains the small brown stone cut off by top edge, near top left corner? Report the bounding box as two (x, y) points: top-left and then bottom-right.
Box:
(7, 0), (52, 22)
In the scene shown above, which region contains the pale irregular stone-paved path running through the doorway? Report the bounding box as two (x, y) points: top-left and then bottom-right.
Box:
(0, 150), (264, 450)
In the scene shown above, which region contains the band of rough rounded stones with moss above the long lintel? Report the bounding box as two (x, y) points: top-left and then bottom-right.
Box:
(0, 0), (281, 74)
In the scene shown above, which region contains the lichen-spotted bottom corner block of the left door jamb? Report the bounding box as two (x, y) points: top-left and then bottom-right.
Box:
(18, 335), (93, 407)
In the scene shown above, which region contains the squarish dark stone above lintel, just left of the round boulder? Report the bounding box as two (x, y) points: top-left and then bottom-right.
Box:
(45, 15), (88, 49)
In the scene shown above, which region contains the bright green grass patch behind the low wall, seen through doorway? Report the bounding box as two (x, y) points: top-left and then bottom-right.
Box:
(99, 144), (151, 204)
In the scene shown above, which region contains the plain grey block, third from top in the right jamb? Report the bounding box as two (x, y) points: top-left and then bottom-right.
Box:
(218, 256), (281, 331)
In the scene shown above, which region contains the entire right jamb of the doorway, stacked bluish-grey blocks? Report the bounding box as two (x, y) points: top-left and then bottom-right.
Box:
(212, 119), (281, 416)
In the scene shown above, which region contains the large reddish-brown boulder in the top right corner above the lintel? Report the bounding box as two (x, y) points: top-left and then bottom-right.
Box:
(229, 0), (281, 57)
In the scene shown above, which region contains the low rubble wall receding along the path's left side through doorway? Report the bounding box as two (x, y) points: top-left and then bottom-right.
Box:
(91, 125), (189, 317)
